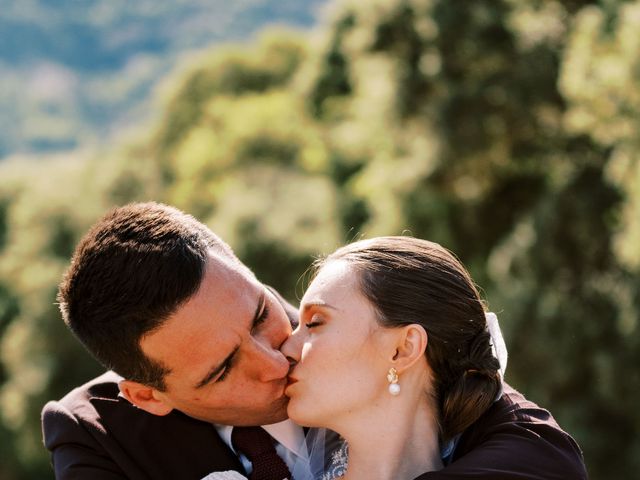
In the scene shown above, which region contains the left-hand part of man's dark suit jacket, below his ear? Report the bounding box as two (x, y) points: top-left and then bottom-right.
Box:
(42, 372), (244, 480)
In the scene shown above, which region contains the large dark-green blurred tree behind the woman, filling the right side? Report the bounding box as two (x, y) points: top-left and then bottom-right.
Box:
(307, 0), (640, 478)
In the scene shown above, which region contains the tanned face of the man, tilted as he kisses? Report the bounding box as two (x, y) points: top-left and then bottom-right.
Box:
(140, 254), (291, 425)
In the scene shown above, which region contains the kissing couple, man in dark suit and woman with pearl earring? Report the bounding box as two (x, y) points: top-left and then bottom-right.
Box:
(42, 203), (587, 480)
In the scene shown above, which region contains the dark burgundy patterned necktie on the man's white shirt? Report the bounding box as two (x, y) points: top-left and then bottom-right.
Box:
(231, 427), (291, 480)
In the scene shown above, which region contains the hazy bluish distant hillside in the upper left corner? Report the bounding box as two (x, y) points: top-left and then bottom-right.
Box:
(0, 0), (326, 158)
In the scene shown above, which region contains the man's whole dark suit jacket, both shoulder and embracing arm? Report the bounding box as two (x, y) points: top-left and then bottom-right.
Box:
(42, 372), (586, 480)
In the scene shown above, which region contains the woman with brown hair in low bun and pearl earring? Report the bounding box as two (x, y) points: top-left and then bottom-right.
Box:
(282, 237), (506, 480)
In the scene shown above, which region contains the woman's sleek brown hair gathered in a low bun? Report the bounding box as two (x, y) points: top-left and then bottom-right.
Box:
(318, 237), (501, 441)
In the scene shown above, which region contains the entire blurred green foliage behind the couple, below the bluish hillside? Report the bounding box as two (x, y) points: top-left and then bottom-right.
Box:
(0, 0), (640, 480)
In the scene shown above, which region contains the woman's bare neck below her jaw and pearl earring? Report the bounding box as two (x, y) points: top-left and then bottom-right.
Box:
(338, 394), (442, 480)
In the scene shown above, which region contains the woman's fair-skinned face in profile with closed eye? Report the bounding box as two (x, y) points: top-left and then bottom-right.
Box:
(282, 261), (394, 430)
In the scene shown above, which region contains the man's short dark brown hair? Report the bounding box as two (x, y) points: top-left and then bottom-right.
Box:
(58, 203), (240, 390)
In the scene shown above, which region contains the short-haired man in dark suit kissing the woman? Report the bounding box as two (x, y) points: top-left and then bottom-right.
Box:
(42, 203), (586, 480)
